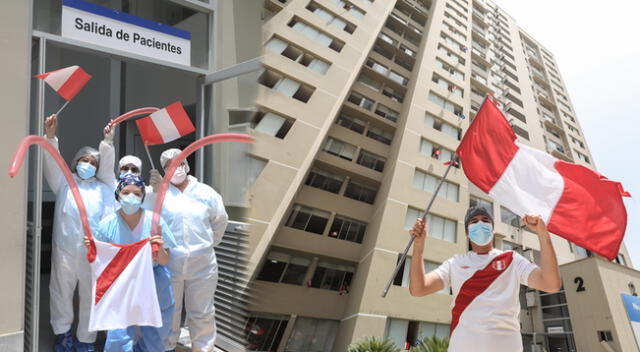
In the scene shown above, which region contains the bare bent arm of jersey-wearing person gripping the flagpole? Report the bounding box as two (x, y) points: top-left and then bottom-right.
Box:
(409, 219), (444, 297)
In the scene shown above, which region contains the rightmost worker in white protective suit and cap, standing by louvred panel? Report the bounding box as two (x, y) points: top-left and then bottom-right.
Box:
(155, 149), (228, 352)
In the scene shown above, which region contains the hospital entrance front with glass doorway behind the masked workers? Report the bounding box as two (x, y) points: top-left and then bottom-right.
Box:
(0, 0), (262, 352)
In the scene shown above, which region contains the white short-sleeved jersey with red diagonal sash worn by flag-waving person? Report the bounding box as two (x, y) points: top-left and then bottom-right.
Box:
(434, 249), (538, 352)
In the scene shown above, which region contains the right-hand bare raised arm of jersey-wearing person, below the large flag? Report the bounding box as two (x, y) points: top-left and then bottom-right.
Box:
(523, 215), (562, 292)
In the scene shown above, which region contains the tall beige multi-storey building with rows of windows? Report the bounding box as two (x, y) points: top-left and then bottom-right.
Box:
(247, 0), (630, 351)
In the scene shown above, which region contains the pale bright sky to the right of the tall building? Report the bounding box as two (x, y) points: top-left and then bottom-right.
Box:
(494, 0), (640, 269)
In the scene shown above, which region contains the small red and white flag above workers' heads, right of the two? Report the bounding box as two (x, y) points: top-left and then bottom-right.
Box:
(136, 101), (196, 145)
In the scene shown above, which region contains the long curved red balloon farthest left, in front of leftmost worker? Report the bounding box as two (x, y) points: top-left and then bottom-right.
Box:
(9, 136), (96, 262)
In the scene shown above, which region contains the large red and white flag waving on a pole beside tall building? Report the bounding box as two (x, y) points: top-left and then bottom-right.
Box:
(457, 99), (629, 260)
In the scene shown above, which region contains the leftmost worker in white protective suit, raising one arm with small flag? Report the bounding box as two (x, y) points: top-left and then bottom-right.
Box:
(44, 115), (115, 352)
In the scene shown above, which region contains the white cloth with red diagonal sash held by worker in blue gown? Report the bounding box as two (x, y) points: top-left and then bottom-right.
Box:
(88, 239), (162, 331)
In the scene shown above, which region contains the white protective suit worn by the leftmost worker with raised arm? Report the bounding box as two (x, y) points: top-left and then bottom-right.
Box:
(44, 138), (115, 343)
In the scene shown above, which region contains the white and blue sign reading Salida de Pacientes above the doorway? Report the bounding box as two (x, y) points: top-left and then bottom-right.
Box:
(62, 0), (191, 66)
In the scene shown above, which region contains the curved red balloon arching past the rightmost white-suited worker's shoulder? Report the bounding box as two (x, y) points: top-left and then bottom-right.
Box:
(151, 133), (254, 253)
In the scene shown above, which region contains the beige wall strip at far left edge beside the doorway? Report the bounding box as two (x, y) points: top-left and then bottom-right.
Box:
(0, 0), (31, 351)
